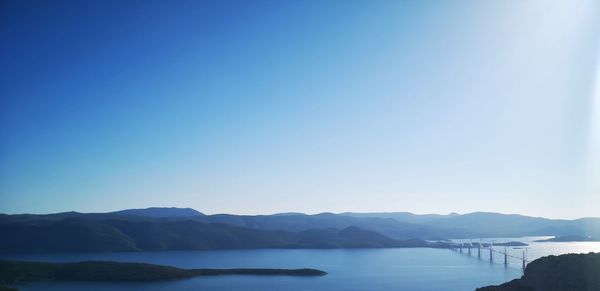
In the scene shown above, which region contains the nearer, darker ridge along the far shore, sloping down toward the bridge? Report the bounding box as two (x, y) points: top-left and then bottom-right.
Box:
(0, 215), (428, 253)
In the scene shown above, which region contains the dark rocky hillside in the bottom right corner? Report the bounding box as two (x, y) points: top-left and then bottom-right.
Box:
(477, 253), (600, 291)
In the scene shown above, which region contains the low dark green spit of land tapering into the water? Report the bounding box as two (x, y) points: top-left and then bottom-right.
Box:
(0, 261), (327, 284)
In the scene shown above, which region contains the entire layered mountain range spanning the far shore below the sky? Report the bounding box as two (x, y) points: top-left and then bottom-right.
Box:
(0, 207), (600, 253)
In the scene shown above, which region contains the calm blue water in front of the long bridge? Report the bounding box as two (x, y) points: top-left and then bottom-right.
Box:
(5, 248), (521, 291)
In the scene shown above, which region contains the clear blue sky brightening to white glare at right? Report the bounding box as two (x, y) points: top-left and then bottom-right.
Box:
(0, 0), (600, 218)
